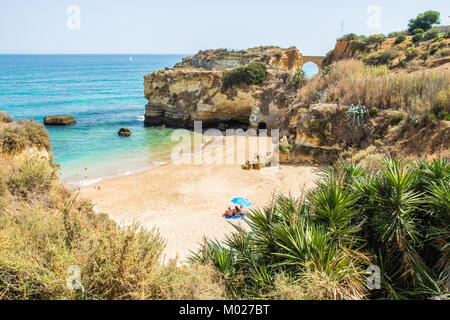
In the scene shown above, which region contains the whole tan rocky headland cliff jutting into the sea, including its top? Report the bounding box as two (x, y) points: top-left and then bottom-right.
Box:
(144, 47), (303, 129)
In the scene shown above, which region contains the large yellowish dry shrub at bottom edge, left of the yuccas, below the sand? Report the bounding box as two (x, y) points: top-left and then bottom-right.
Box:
(76, 219), (168, 299)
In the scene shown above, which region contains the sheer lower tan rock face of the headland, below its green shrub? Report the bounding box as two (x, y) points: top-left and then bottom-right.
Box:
(144, 68), (298, 129)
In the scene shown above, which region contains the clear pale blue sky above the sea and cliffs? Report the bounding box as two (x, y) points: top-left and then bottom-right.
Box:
(0, 0), (450, 55)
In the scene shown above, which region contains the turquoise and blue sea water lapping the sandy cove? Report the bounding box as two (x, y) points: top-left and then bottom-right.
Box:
(0, 55), (183, 185)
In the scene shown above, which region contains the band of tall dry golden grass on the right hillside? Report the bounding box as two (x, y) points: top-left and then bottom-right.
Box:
(299, 60), (450, 115)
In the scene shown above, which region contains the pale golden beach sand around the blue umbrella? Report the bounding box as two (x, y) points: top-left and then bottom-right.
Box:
(81, 137), (320, 260)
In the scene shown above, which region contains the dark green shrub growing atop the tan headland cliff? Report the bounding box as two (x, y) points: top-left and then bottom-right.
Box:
(223, 62), (267, 88)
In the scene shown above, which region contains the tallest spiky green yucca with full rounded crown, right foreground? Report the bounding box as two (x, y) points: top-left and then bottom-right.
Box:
(360, 158), (435, 296)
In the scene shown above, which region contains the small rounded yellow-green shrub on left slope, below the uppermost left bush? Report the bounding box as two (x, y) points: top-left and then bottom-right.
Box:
(7, 157), (56, 198)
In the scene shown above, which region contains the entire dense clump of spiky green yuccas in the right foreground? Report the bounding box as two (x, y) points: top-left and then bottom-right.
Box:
(189, 158), (450, 299)
